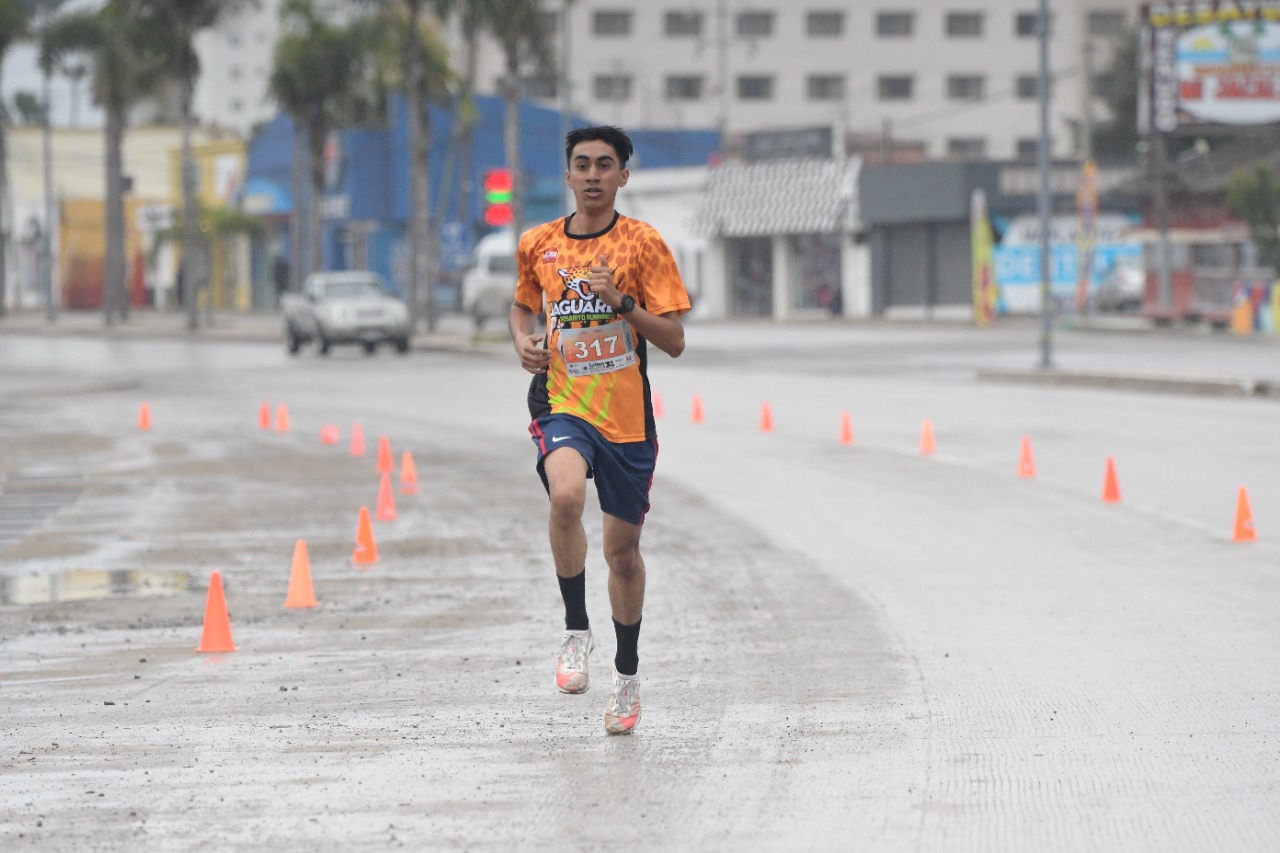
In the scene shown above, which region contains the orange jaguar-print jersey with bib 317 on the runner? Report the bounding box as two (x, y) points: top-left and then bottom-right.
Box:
(516, 214), (690, 442)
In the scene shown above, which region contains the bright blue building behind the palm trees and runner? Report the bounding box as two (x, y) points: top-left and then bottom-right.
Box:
(242, 96), (718, 310)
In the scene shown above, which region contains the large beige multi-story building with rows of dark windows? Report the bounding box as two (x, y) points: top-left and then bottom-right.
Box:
(465, 0), (1139, 159)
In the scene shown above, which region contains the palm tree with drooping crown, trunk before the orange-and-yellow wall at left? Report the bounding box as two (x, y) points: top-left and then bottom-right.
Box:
(40, 0), (165, 325)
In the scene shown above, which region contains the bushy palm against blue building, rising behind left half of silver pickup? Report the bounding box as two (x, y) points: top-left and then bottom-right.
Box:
(268, 0), (369, 275)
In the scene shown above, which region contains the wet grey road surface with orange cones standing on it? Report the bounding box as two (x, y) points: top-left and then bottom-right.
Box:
(0, 324), (1280, 850)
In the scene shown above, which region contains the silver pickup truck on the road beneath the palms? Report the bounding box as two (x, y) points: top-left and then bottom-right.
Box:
(280, 272), (413, 355)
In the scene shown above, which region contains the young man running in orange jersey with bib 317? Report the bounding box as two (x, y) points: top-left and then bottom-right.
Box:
(508, 126), (690, 734)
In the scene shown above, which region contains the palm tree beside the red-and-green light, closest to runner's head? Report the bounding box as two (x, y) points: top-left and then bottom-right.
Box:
(439, 0), (556, 234)
